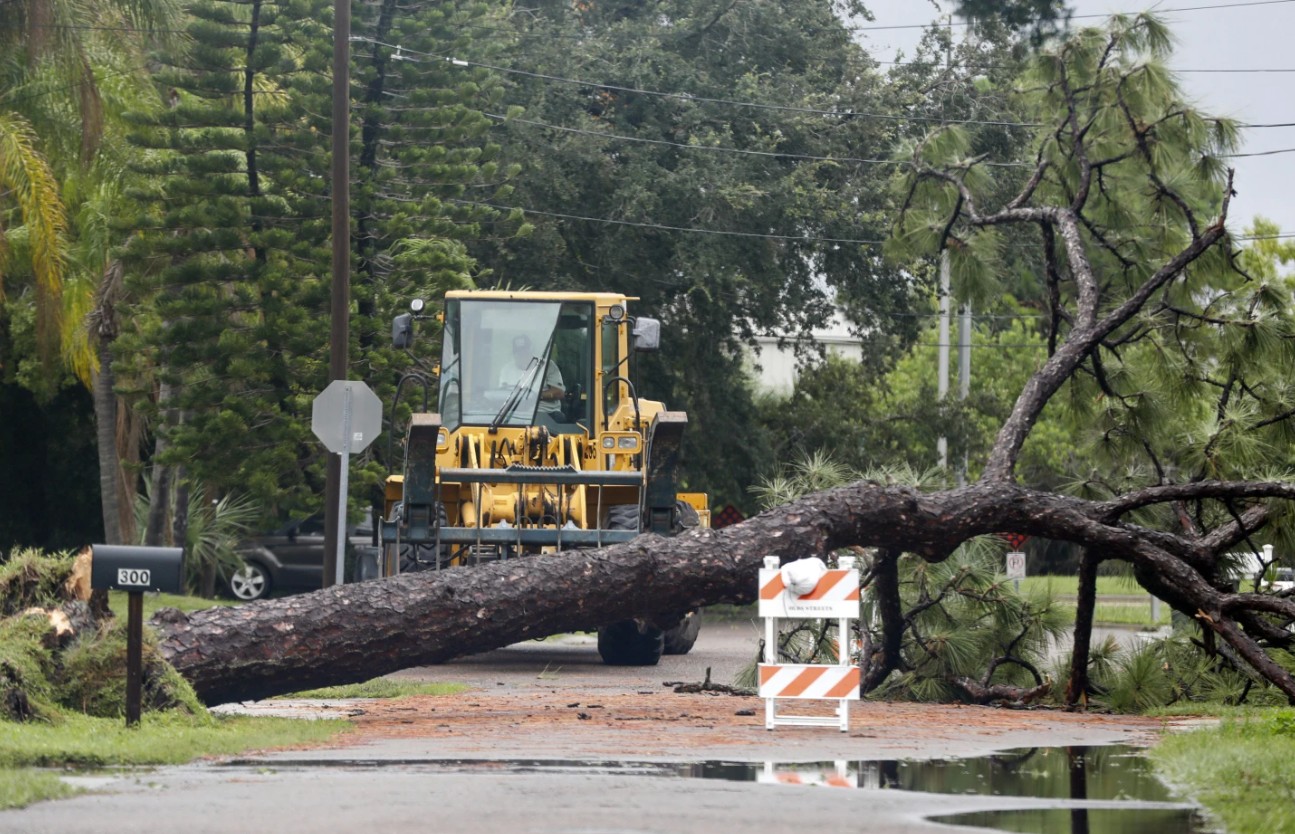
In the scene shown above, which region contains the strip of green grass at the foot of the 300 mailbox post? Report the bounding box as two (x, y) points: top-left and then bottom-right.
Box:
(0, 714), (350, 768)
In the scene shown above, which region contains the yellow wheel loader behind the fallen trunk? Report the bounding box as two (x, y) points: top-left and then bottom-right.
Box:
(381, 291), (710, 666)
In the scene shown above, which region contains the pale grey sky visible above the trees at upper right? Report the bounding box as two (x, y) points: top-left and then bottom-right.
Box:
(860, 0), (1295, 240)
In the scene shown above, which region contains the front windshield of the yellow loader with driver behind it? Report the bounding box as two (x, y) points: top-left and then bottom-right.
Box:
(440, 299), (593, 433)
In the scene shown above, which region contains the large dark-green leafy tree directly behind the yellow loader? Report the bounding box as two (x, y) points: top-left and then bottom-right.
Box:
(475, 0), (958, 500)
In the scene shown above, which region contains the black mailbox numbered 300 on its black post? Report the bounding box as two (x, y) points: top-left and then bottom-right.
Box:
(89, 544), (184, 727)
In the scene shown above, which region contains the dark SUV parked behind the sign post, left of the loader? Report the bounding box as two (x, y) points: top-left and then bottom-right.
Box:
(225, 515), (377, 600)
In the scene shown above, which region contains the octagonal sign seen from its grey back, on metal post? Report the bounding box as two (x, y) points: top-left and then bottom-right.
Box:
(311, 379), (382, 585)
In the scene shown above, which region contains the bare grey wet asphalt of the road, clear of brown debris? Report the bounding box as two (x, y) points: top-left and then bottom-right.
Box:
(0, 622), (1186, 834)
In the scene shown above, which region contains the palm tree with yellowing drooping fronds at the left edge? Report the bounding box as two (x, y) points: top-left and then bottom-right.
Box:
(0, 0), (180, 543)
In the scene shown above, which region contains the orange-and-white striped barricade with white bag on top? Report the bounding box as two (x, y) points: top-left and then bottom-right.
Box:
(759, 556), (860, 733)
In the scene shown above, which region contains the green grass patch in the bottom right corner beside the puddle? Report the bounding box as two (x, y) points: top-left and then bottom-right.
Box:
(1151, 708), (1295, 834)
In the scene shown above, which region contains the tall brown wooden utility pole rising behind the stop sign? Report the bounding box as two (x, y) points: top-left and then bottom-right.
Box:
(324, 0), (351, 588)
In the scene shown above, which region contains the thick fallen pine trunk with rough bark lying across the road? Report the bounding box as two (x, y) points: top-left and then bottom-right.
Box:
(154, 482), (1295, 703)
